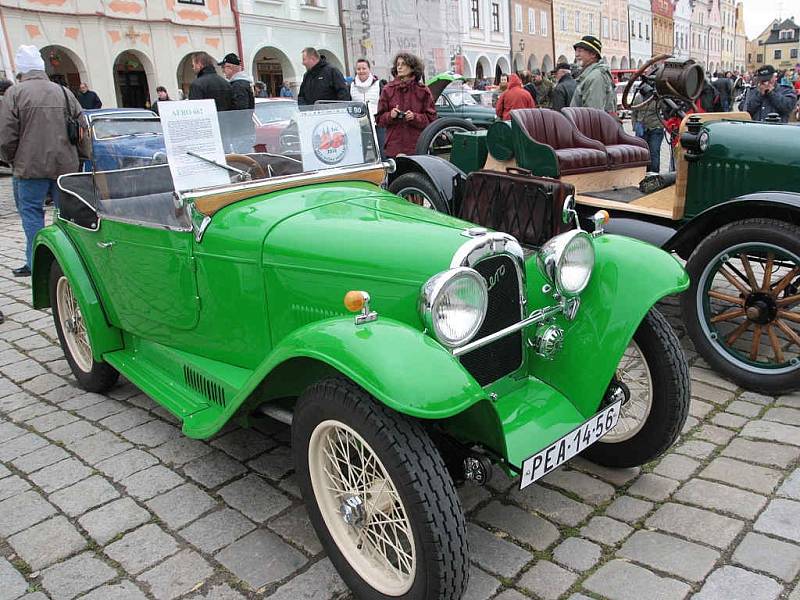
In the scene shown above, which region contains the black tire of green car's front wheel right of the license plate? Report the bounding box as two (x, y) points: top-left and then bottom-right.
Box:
(583, 309), (690, 468)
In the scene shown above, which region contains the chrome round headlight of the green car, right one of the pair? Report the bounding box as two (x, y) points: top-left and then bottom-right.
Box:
(539, 231), (594, 296)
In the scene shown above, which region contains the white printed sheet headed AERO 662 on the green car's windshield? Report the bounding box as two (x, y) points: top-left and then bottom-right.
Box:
(158, 100), (231, 191)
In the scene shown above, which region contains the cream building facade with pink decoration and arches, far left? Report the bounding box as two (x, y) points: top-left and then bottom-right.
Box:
(0, 0), (238, 107)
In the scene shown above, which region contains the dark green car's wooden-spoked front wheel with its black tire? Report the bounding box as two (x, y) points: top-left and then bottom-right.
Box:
(681, 219), (800, 395)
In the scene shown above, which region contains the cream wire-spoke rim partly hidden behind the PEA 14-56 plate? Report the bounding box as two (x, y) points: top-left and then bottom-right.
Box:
(603, 341), (653, 444)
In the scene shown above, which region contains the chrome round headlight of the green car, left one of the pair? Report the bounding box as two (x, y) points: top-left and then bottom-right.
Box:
(420, 267), (489, 348)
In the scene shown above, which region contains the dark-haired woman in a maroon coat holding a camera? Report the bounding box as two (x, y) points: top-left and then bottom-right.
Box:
(376, 52), (436, 157)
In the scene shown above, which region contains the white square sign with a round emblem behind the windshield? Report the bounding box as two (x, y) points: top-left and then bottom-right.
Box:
(297, 107), (364, 171)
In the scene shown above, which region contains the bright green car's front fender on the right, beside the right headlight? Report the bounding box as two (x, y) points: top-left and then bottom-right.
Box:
(528, 235), (689, 418)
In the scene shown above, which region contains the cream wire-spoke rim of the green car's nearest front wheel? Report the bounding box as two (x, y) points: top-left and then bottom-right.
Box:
(308, 420), (417, 596)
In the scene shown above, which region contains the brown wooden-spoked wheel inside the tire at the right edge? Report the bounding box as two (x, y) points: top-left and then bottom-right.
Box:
(696, 243), (800, 374)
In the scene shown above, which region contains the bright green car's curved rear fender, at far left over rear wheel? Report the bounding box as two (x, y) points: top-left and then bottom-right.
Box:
(32, 226), (123, 361)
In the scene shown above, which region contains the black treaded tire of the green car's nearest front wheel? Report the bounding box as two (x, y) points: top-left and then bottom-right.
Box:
(292, 377), (469, 600)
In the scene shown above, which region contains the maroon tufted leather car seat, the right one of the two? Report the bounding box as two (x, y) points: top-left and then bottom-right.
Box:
(562, 107), (650, 169)
